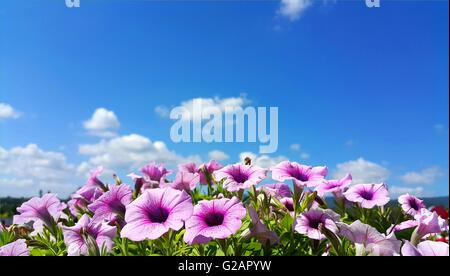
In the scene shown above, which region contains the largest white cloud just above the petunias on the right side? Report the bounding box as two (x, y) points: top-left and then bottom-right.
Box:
(333, 158), (390, 184)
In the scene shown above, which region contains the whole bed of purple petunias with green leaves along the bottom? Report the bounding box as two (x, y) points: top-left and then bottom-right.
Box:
(0, 161), (449, 256)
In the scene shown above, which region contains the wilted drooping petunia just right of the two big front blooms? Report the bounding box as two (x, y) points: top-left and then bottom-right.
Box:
(241, 207), (280, 245)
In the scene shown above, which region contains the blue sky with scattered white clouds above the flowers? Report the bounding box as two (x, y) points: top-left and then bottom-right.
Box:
(0, 0), (449, 196)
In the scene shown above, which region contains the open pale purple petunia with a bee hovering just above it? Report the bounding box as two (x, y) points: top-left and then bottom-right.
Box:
(214, 164), (267, 192)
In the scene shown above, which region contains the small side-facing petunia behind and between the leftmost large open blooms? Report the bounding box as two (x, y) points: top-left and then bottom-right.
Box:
(67, 185), (103, 217)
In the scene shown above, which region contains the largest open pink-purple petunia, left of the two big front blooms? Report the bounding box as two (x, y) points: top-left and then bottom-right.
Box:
(121, 187), (194, 241)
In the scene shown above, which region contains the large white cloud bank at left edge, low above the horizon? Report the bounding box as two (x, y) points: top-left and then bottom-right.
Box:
(0, 144), (80, 196)
